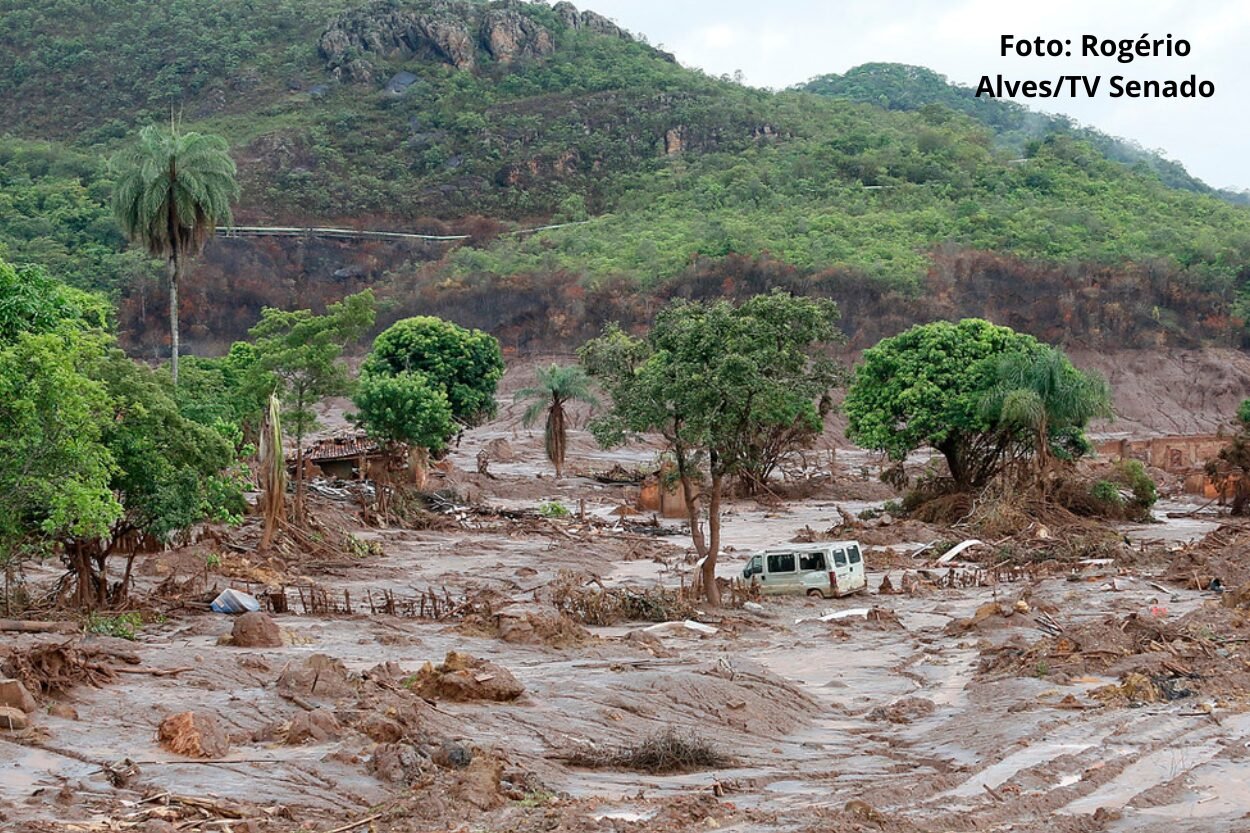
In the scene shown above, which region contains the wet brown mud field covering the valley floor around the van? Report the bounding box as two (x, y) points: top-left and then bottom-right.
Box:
(0, 392), (1250, 833)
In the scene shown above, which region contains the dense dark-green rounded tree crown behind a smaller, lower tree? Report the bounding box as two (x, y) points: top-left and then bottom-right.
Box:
(361, 315), (504, 427)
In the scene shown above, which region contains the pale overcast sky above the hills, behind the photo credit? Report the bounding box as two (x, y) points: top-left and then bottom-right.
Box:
(576, 0), (1250, 189)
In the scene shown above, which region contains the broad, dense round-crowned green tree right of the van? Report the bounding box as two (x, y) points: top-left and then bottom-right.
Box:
(843, 319), (1105, 490)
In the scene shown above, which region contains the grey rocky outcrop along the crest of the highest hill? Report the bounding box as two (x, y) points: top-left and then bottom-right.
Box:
(318, 0), (634, 84)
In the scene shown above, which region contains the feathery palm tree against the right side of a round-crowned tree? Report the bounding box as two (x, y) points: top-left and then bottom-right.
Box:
(981, 346), (1113, 489)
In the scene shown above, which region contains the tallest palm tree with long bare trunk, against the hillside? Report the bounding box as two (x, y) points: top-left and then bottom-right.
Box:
(111, 124), (239, 385)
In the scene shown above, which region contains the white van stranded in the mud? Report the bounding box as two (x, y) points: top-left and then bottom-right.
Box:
(743, 540), (868, 599)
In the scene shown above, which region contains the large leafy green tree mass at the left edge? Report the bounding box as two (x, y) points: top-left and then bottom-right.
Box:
(0, 250), (243, 607)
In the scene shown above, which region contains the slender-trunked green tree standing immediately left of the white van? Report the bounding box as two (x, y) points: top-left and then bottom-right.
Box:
(579, 293), (840, 605)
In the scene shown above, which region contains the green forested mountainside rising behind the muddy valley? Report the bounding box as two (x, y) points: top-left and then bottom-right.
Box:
(0, 0), (1250, 349)
